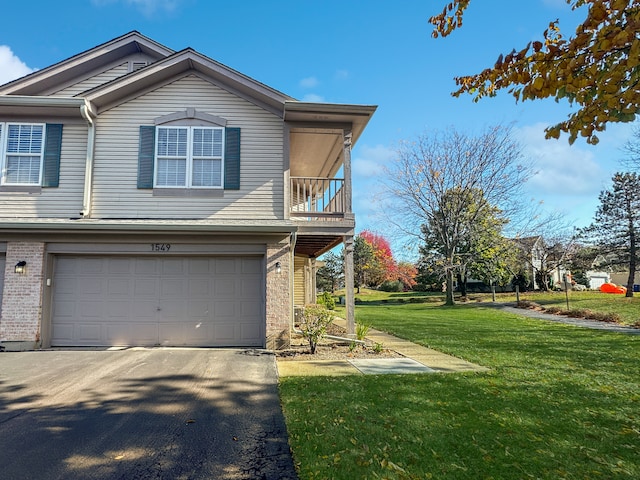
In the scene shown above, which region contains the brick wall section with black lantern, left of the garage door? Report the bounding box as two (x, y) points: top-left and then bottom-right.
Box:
(0, 242), (44, 346)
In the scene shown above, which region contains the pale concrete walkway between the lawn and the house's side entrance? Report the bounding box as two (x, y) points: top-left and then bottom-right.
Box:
(277, 318), (488, 377)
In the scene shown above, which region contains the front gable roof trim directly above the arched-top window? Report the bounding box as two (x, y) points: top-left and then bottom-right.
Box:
(81, 48), (293, 117)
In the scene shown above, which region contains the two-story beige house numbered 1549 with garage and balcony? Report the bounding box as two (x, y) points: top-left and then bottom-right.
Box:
(0, 32), (375, 349)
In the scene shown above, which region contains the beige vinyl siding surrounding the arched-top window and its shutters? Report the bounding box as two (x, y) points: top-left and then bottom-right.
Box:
(93, 75), (284, 220)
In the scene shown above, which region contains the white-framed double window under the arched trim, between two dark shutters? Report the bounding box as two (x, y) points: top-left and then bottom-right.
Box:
(154, 126), (224, 188)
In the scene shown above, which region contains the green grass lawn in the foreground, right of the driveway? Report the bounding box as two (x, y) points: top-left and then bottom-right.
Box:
(280, 299), (640, 480)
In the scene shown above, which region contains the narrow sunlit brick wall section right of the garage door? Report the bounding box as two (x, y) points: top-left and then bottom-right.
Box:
(266, 240), (293, 350)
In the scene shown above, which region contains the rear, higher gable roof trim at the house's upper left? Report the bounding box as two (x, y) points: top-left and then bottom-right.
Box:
(0, 31), (174, 95)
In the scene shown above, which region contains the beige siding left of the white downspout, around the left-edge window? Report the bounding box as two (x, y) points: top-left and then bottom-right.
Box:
(0, 124), (87, 218)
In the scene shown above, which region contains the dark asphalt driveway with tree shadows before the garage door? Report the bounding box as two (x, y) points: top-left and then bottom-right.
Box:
(0, 348), (297, 480)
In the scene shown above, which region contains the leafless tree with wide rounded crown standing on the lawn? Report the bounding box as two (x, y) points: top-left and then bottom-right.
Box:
(383, 126), (532, 304)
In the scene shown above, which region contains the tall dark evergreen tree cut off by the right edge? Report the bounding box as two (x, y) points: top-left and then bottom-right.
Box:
(582, 173), (640, 297)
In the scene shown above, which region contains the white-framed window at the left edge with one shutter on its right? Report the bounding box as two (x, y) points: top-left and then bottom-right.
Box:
(0, 123), (45, 185)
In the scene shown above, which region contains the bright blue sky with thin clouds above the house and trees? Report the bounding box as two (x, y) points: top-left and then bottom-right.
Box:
(0, 0), (632, 255)
